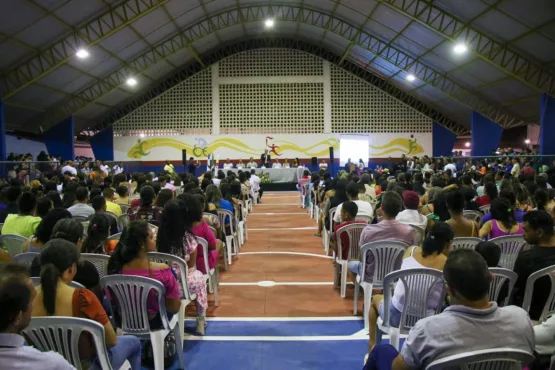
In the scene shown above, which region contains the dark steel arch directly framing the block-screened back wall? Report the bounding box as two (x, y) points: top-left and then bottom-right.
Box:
(80, 38), (470, 136)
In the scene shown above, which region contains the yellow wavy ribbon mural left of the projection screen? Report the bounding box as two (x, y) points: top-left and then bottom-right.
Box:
(127, 136), (339, 159)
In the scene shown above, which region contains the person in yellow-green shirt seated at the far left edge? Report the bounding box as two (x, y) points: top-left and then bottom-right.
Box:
(2, 192), (41, 238)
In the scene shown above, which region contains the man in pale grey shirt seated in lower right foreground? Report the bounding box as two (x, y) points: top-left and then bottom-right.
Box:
(364, 249), (534, 370)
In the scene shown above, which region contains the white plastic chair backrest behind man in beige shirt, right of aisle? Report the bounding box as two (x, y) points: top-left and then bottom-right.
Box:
(360, 240), (409, 289)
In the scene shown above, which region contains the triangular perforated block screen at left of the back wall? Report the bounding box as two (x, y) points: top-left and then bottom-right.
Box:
(114, 68), (212, 136)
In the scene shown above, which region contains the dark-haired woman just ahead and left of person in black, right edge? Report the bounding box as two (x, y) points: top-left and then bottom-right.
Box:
(479, 198), (522, 239)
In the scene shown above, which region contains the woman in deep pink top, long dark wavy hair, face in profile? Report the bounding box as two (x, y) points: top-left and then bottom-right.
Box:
(108, 221), (185, 329)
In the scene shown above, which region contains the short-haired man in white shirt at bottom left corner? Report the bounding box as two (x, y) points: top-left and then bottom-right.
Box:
(0, 263), (75, 370)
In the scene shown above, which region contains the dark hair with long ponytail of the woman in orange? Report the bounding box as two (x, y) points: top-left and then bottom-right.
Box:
(39, 239), (79, 316)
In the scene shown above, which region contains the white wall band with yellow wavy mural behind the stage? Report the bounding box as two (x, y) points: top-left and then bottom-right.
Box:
(114, 133), (433, 161)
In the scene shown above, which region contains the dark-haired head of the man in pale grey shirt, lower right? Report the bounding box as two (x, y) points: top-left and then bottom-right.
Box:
(443, 249), (491, 302)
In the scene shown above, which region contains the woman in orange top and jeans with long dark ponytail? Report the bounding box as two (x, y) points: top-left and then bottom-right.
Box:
(32, 239), (141, 370)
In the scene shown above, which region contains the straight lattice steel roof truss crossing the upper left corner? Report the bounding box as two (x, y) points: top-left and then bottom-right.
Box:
(1, 0), (168, 99)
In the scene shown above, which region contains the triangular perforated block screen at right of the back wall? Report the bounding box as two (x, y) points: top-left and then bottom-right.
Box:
(331, 65), (432, 133)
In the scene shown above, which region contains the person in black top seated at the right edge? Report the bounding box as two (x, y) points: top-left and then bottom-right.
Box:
(512, 211), (555, 320)
